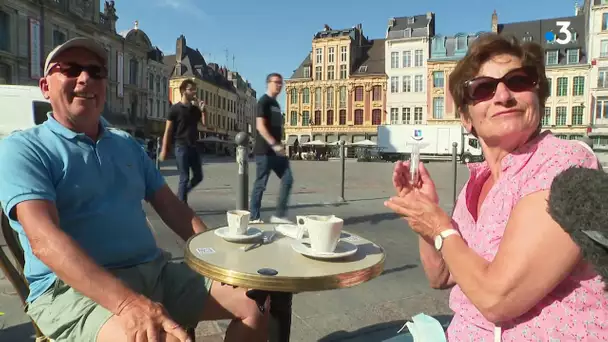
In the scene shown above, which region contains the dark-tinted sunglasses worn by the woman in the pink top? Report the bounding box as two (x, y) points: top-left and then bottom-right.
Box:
(464, 67), (539, 102)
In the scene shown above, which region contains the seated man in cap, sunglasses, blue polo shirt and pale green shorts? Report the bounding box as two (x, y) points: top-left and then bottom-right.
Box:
(0, 38), (267, 342)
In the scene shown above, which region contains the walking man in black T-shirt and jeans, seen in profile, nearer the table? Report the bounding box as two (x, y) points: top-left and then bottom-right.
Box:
(249, 73), (293, 223)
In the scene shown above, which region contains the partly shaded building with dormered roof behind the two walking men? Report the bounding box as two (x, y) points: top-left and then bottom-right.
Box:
(165, 35), (257, 143)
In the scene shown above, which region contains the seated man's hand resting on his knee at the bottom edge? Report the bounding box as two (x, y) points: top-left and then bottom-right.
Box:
(116, 295), (192, 342)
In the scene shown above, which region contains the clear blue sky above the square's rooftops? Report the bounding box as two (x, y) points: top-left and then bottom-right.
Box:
(113, 0), (583, 104)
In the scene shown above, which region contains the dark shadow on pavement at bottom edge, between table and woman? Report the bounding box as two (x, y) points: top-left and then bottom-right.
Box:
(319, 315), (453, 342)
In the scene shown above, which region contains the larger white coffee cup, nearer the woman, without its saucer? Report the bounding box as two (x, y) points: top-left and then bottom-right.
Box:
(296, 215), (344, 253)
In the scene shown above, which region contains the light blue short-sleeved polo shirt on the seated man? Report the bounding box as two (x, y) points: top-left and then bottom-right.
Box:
(0, 113), (165, 302)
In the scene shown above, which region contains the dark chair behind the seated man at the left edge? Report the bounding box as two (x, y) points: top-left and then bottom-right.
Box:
(0, 210), (52, 342)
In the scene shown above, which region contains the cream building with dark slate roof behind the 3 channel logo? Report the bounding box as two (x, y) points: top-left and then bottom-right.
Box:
(496, 8), (592, 139)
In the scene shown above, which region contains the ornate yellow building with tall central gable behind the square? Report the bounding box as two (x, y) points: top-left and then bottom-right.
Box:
(285, 24), (386, 146)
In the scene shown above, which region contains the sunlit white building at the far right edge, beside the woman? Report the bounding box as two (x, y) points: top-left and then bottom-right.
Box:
(586, 0), (608, 149)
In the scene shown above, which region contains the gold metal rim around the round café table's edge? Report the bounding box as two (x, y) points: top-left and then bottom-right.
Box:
(184, 233), (386, 293)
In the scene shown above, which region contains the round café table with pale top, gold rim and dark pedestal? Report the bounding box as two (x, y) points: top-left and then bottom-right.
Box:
(184, 224), (385, 342)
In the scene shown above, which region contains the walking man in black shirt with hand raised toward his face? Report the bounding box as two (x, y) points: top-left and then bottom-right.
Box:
(159, 80), (205, 203)
